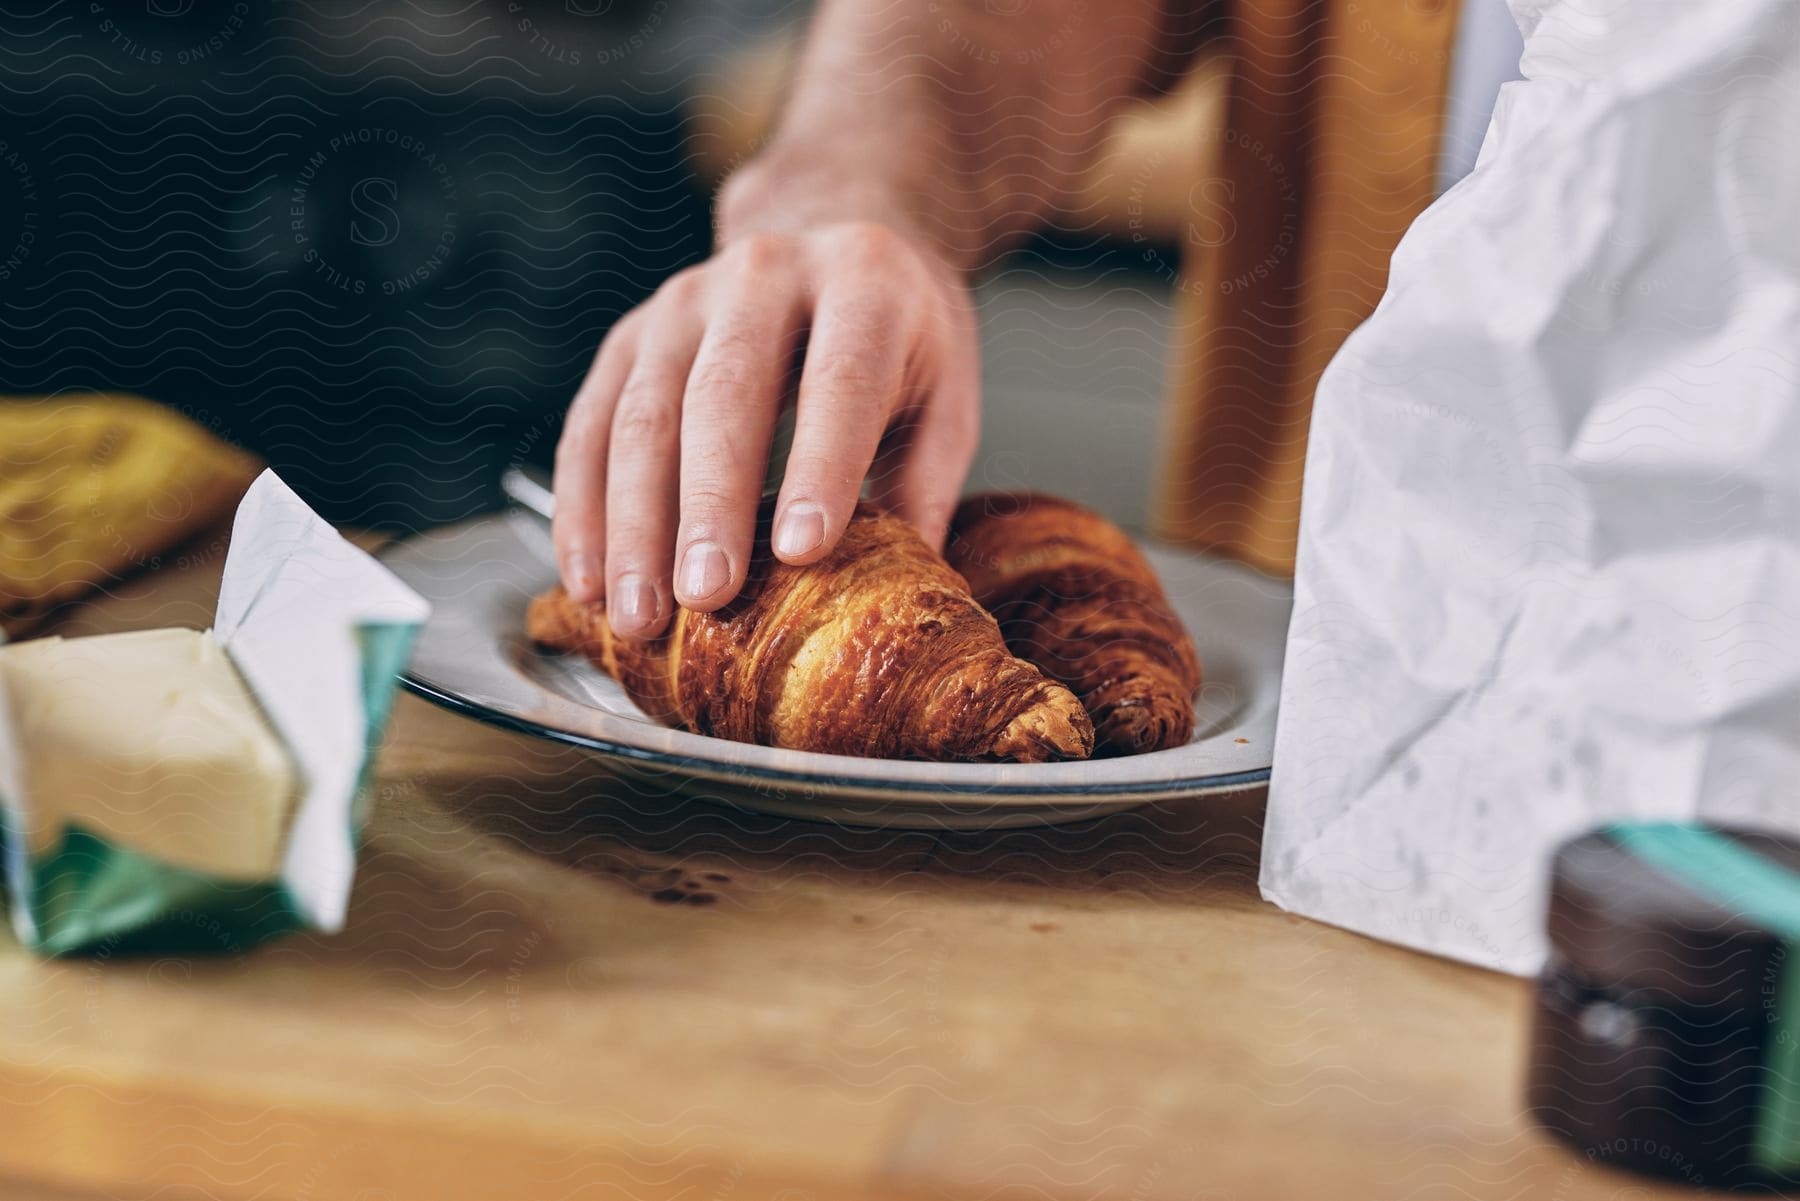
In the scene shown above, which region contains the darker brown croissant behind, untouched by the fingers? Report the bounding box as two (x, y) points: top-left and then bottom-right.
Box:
(947, 493), (1201, 754)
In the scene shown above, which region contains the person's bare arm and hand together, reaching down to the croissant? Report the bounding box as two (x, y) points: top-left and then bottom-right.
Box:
(553, 0), (1193, 626)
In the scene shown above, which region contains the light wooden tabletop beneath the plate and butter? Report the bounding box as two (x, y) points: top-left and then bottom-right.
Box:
(0, 556), (1713, 1201)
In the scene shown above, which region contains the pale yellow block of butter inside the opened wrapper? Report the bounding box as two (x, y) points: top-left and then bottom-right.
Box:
(0, 628), (301, 880)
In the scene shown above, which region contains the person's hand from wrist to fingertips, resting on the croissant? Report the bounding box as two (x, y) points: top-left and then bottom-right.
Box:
(554, 220), (979, 637)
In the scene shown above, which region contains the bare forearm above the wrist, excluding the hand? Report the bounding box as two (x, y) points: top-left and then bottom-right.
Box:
(718, 0), (1170, 270)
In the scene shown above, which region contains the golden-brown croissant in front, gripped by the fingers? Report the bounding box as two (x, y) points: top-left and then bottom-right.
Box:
(526, 502), (1093, 763)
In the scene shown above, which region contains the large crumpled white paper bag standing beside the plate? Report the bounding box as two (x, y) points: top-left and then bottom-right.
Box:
(1262, 0), (1800, 972)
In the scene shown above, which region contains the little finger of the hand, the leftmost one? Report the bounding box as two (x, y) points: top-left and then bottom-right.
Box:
(551, 313), (637, 601)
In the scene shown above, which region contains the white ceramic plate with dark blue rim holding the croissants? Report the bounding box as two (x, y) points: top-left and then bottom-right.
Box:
(382, 510), (1292, 828)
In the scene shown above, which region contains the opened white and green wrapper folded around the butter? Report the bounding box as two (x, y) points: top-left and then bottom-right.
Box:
(0, 472), (430, 954)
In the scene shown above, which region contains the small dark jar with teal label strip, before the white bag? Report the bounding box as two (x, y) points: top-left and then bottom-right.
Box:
(1528, 823), (1800, 1187)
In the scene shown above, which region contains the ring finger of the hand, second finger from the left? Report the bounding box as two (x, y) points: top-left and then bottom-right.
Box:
(607, 288), (700, 637)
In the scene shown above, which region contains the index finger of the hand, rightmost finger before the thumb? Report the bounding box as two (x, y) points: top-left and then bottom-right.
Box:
(770, 244), (911, 564)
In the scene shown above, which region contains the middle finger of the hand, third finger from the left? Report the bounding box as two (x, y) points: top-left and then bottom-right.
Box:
(675, 238), (799, 612)
